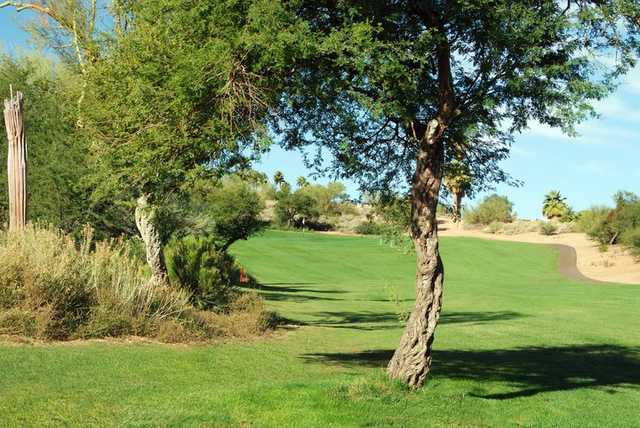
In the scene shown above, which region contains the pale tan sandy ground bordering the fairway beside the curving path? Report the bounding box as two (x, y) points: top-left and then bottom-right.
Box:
(438, 222), (640, 284)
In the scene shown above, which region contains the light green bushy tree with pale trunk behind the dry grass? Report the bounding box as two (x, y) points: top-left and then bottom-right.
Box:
(82, 0), (308, 279)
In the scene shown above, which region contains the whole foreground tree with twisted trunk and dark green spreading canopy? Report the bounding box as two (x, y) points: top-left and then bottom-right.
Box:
(274, 0), (640, 387)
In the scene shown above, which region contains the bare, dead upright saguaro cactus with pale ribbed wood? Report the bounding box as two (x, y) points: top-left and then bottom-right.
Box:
(4, 90), (27, 231)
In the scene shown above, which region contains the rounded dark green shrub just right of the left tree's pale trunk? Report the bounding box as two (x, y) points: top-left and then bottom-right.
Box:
(166, 236), (240, 309)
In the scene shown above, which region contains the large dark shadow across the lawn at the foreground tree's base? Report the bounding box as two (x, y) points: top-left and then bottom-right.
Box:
(303, 344), (640, 400)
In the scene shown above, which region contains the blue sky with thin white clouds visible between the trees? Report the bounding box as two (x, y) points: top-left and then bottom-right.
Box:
(0, 9), (640, 218)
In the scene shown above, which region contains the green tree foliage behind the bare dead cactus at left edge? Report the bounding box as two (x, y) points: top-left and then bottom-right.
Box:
(0, 56), (91, 231)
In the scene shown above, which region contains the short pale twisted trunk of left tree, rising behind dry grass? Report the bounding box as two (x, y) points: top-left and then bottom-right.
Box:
(135, 195), (167, 282)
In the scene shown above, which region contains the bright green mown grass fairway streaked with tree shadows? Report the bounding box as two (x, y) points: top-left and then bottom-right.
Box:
(0, 231), (640, 427)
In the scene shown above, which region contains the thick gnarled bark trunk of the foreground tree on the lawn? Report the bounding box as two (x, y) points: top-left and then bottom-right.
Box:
(387, 119), (444, 388)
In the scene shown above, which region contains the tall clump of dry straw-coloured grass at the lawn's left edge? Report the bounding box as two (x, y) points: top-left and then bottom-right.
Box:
(0, 226), (271, 341)
